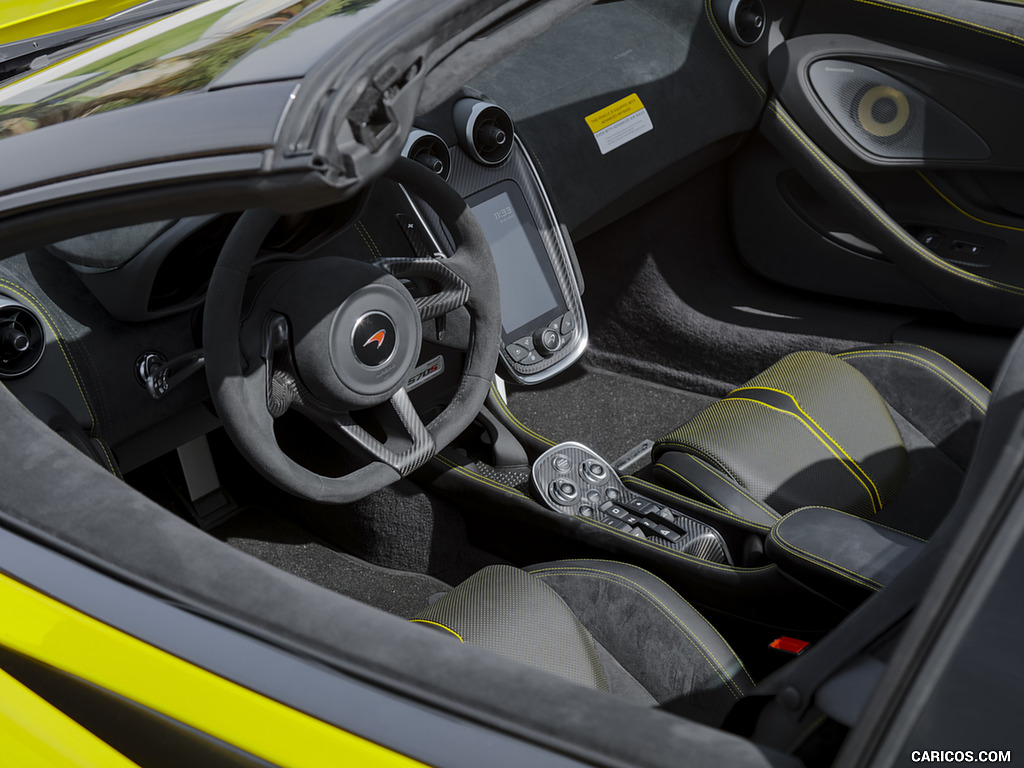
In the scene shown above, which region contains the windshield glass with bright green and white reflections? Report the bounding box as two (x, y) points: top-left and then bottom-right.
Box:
(0, 0), (368, 138)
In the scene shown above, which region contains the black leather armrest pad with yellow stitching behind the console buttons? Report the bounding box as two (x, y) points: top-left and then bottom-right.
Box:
(765, 507), (926, 605)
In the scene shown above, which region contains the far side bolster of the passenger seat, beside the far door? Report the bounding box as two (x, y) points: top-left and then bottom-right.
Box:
(836, 344), (991, 470)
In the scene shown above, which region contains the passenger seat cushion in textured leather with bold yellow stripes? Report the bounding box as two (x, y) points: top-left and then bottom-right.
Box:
(655, 351), (908, 516)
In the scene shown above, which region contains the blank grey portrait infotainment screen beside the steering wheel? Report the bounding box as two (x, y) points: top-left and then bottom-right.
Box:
(466, 180), (567, 341)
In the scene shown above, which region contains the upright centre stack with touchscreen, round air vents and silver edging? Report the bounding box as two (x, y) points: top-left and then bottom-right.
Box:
(406, 97), (588, 384)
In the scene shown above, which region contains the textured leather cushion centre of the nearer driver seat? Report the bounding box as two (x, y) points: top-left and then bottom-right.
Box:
(412, 565), (608, 691)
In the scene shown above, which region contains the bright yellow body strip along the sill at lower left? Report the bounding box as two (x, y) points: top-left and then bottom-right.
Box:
(0, 575), (422, 768)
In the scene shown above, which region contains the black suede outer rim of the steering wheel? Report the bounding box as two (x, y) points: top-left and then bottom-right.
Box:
(203, 159), (501, 504)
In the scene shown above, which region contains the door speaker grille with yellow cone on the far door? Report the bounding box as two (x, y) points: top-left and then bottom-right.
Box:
(809, 58), (989, 160)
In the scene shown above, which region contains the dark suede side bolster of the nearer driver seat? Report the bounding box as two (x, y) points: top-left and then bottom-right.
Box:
(526, 560), (754, 724)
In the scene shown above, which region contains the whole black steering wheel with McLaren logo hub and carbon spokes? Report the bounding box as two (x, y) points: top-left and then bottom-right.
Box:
(203, 159), (501, 504)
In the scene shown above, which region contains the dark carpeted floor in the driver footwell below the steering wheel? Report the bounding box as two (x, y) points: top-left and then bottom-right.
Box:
(212, 509), (452, 618)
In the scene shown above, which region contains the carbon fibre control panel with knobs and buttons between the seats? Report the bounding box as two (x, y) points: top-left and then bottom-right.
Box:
(530, 442), (732, 565)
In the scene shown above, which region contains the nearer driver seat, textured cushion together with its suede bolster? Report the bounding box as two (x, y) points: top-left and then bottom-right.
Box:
(412, 560), (754, 725)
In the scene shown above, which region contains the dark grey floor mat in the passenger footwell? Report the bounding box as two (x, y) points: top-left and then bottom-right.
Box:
(508, 358), (714, 462)
